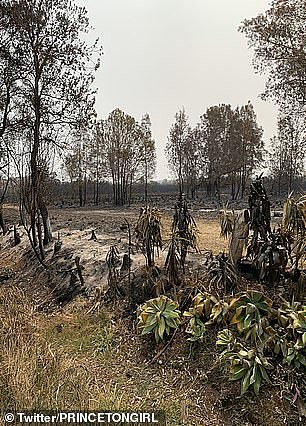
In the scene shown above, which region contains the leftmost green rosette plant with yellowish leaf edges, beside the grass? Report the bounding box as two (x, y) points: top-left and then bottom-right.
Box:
(138, 296), (181, 343)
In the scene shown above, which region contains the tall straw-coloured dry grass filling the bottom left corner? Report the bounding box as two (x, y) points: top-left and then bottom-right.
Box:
(0, 288), (89, 411)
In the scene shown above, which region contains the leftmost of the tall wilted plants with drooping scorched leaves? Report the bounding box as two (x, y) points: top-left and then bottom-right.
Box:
(135, 206), (163, 267)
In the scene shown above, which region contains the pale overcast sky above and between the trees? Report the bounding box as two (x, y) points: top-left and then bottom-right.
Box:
(78, 0), (276, 179)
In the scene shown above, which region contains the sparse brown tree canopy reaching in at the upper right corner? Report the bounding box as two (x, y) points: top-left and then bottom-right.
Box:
(240, 0), (306, 105)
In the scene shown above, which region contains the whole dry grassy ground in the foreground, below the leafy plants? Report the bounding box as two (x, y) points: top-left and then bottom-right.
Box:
(0, 286), (296, 426)
